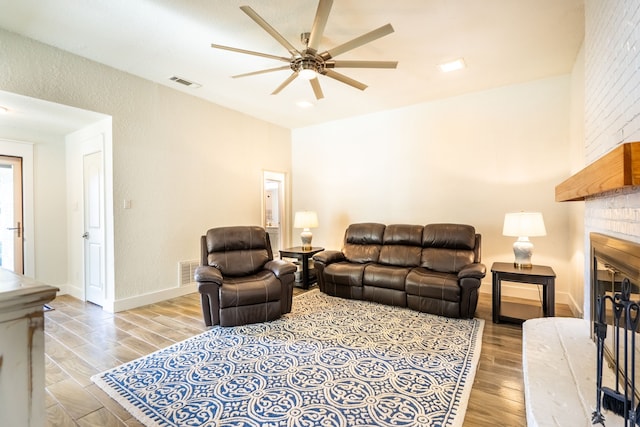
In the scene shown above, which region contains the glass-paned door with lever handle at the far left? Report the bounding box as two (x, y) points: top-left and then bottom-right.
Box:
(0, 156), (24, 274)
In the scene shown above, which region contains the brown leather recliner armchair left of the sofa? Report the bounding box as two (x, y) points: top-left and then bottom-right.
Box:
(195, 226), (296, 326)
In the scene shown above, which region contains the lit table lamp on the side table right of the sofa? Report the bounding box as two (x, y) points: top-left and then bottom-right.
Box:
(502, 212), (547, 268)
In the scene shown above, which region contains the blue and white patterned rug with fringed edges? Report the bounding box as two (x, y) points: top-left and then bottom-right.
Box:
(92, 290), (484, 427)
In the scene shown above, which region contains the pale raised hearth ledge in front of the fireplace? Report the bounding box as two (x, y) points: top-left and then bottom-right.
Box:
(522, 317), (624, 427)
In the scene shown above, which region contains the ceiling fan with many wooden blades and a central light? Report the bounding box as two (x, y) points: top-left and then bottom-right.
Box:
(211, 0), (398, 99)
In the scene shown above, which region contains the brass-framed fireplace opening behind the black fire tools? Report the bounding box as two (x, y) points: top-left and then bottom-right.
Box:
(590, 233), (640, 402)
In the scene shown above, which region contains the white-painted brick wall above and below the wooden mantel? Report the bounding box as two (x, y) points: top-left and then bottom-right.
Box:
(584, 0), (640, 244)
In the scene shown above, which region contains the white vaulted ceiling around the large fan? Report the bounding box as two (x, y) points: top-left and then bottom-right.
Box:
(0, 0), (584, 132)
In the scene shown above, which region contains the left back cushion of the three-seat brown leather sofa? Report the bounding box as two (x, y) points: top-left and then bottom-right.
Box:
(343, 222), (385, 264)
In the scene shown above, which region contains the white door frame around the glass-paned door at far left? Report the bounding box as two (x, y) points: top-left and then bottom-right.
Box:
(0, 139), (36, 278)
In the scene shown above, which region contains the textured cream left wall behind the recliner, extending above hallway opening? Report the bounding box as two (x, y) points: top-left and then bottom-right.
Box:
(0, 31), (291, 308)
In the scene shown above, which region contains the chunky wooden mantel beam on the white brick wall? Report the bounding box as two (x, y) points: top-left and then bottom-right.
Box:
(556, 142), (640, 202)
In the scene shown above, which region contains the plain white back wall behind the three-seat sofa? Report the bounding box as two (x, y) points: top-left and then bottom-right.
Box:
(292, 76), (571, 302)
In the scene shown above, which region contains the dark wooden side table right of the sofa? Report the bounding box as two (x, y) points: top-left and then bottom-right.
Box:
(491, 262), (556, 323)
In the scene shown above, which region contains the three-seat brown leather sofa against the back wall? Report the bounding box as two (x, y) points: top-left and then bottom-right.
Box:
(313, 223), (486, 318)
